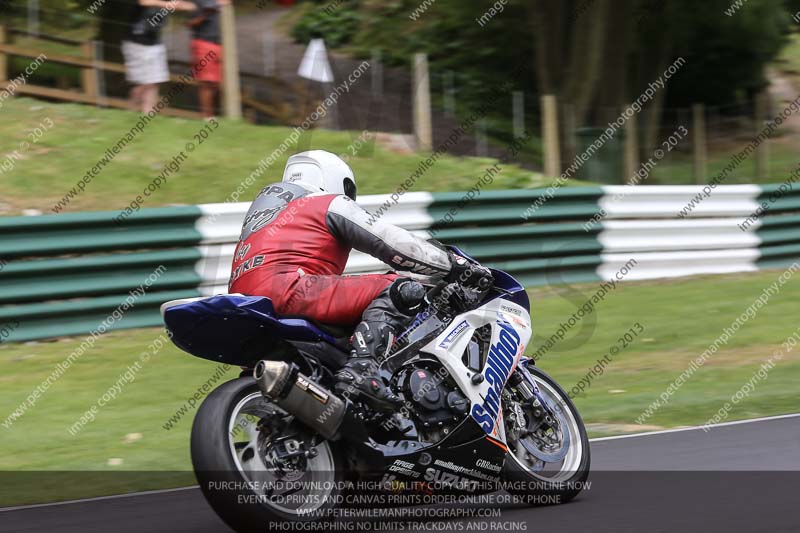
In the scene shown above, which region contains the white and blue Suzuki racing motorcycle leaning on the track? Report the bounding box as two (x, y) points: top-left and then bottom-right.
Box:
(161, 247), (590, 531)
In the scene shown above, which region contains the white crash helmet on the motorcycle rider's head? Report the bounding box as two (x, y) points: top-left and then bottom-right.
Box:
(282, 150), (356, 200)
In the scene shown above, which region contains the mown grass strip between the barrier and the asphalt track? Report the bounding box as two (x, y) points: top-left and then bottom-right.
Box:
(0, 271), (800, 505)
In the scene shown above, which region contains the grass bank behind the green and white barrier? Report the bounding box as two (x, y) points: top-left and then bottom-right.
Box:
(0, 96), (564, 215)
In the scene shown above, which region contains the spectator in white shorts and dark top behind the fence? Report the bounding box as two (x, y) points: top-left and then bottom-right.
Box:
(122, 0), (196, 113)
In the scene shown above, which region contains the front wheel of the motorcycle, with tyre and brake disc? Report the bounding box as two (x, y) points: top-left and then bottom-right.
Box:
(503, 364), (591, 505)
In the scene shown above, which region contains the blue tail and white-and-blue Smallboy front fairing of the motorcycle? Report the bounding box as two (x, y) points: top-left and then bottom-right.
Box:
(161, 248), (532, 443)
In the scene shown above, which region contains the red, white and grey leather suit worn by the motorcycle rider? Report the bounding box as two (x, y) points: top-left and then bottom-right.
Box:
(229, 182), (451, 325)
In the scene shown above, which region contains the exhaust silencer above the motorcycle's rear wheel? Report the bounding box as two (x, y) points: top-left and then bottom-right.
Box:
(253, 361), (347, 440)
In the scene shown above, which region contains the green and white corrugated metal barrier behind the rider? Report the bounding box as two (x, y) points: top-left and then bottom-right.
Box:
(0, 184), (800, 342)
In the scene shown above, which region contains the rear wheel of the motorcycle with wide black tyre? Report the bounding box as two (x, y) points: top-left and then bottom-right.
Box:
(191, 377), (345, 531)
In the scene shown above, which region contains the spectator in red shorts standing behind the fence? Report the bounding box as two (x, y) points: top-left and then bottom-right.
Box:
(189, 0), (231, 118)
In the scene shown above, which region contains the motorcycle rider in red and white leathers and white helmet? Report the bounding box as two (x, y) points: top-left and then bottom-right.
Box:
(229, 150), (490, 411)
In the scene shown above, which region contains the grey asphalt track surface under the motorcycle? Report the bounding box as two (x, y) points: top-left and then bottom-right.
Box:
(0, 415), (800, 533)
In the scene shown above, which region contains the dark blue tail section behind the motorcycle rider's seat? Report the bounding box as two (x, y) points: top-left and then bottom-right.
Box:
(164, 294), (335, 366)
